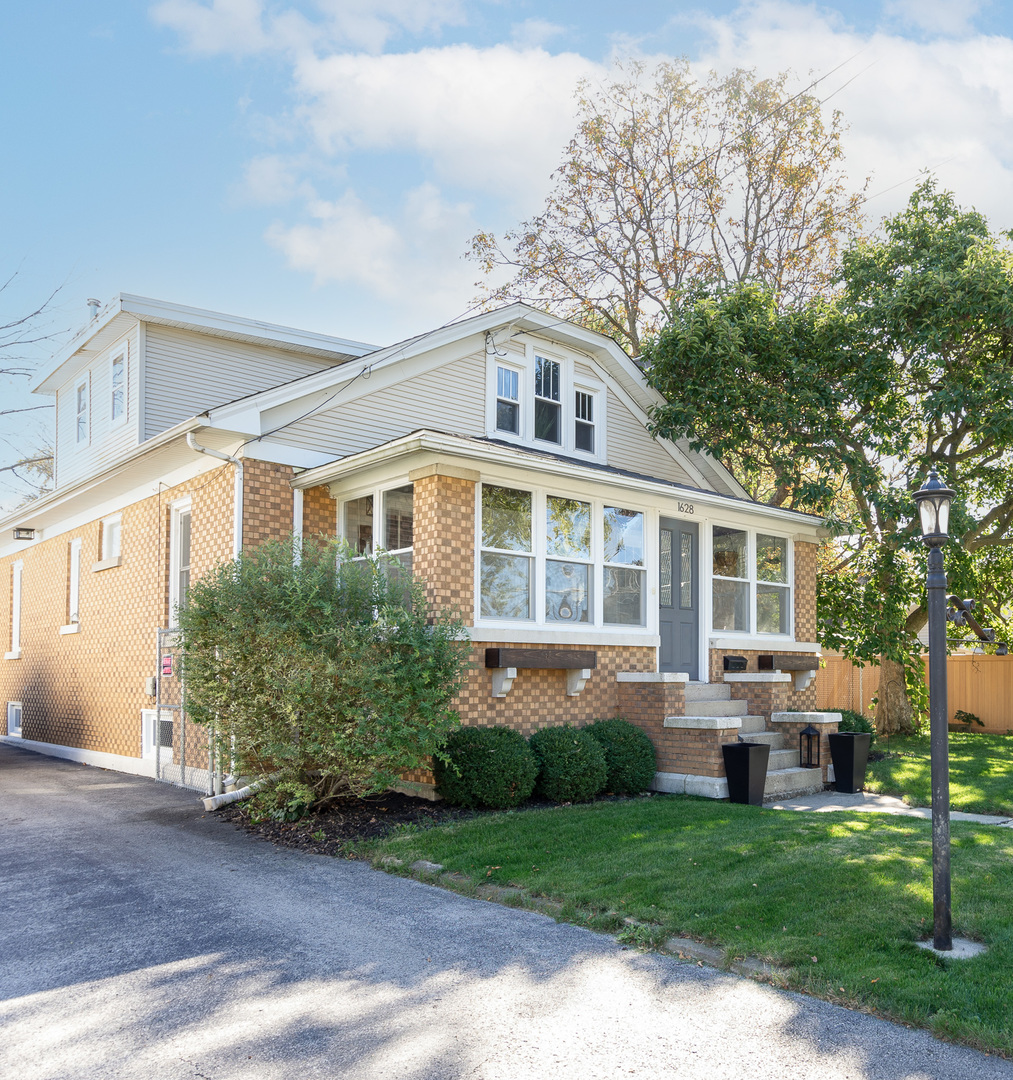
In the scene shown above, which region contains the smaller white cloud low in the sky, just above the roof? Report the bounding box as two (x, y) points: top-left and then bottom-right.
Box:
(267, 184), (475, 319)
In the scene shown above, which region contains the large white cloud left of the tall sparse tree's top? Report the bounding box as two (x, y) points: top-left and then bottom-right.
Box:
(295, 45), (600, 206)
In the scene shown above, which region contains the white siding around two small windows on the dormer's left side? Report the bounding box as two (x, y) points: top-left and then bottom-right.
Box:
(56, 325), (140, 487)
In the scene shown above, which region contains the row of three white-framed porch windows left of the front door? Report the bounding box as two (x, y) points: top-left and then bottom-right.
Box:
(478, 484), (646, 626)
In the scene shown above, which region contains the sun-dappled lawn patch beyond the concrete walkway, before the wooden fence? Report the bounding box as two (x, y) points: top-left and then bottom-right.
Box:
(865, 731), (1013, 816)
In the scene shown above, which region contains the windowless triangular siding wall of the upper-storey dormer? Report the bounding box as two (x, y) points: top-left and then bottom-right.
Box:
(144, 323), (347, 438)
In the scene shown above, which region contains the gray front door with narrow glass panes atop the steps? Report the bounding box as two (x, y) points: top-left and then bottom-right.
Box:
(658, 517), (700, 679)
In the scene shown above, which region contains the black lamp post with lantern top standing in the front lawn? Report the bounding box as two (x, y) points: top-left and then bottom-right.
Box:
(915, 469), (956, 951)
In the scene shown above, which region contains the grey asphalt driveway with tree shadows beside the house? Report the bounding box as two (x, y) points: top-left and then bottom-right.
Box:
(0, 744), (1013, 1080)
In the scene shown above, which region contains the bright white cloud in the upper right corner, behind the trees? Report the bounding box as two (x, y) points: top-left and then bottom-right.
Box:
(699, 2), (1013, 229)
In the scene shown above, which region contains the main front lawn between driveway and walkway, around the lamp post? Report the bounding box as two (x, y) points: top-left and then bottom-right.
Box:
(360, 796), (1013, 1056)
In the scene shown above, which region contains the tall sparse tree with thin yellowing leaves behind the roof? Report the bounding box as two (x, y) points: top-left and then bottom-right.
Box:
(470, 59), (863, 355)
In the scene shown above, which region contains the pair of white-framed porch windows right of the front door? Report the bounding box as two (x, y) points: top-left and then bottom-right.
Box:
(713, 525), (792, 634)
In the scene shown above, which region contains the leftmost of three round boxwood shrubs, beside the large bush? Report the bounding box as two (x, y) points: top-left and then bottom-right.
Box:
(433, 728), (538, 810)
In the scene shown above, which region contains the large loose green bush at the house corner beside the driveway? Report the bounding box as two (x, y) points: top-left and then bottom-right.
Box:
(179, 540), (469, 806)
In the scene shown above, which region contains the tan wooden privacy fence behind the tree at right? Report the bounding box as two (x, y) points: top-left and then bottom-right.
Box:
(814, 653), (1013, 734)
